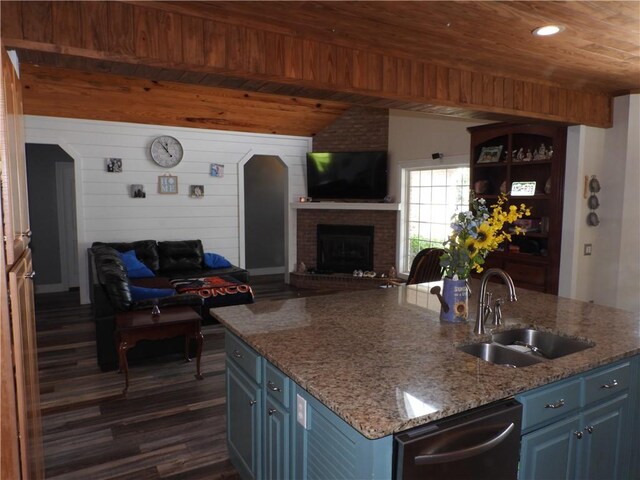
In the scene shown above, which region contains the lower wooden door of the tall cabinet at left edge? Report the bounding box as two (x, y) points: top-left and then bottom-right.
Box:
(9, 249), (44, 480)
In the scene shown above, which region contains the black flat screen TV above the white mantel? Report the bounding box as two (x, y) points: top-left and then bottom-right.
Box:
(307, 152), (387, 201)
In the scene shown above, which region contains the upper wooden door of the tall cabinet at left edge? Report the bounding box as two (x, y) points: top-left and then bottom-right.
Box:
(0, 46), (31, 265)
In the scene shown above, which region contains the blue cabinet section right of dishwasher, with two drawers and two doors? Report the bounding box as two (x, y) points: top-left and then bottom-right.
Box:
(516, 357), (640, 480)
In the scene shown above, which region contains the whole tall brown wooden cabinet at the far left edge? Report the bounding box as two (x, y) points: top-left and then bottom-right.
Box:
(0, 45), (44, 480)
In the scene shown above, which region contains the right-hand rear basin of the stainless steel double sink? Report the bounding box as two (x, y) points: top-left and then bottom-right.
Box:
(491, 328), (593, 359)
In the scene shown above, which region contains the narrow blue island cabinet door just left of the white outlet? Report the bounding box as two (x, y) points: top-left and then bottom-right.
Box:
(264, 396), (291, 480)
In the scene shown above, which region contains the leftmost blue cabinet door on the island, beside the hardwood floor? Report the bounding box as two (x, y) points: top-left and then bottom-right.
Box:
(226, 362), (262, 479)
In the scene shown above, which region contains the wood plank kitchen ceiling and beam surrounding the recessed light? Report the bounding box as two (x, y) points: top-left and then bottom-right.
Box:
(1, 1), (640, 127)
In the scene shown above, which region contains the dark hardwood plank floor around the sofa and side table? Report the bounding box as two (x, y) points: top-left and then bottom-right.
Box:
(36, 275), (329, 480)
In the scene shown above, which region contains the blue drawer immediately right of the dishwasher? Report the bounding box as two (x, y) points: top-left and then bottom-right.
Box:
(516, 379), (580, 430)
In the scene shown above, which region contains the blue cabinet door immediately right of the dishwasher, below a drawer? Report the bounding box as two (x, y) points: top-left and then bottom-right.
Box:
(518, 415), (584, 480)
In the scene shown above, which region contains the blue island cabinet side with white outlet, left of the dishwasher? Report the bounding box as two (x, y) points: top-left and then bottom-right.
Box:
(225, 332), (393, 480)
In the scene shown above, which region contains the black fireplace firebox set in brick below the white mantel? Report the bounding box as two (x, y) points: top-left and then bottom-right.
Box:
(317, 224), (373, 273)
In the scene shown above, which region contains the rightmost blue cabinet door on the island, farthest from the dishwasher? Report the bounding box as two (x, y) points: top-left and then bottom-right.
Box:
(578, 393), (637, 480)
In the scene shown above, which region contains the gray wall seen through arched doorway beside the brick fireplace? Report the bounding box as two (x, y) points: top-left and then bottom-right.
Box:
(244, 155), (287, 273)
